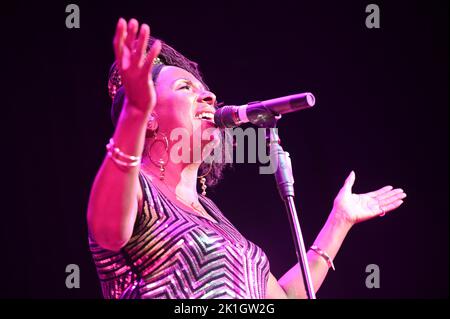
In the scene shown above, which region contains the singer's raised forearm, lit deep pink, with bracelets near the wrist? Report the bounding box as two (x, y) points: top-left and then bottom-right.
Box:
(88, 101), (147, 250)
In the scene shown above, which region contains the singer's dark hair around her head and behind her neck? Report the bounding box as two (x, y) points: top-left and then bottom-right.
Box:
(108, 37), (230, 186)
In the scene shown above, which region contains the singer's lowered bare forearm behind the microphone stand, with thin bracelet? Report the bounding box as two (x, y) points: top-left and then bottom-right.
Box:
(278, 211), (351, 298)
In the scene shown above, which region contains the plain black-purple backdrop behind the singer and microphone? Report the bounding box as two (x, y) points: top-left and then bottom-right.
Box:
(0, 1), (449, 298)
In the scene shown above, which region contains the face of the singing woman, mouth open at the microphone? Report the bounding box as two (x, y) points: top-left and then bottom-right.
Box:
(155, 66), (220, 164)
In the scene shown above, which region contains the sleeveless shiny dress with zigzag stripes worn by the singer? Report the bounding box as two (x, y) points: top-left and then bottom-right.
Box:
(89, 174), (269, 299)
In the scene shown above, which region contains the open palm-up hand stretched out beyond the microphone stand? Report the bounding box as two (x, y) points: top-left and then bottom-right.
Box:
(333, 171), (406, 225)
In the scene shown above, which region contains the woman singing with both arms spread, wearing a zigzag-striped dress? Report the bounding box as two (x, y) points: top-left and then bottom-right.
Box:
(87, 19), (406, 299)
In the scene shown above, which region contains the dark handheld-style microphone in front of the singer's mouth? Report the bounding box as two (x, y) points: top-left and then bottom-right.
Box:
(214, 92), (316, 128)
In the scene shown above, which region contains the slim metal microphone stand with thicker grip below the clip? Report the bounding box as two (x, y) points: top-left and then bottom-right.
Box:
(261, 115), (316, 299)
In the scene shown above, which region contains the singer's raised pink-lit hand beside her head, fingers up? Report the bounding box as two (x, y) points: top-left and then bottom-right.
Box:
(114, 18), (161, 114)
